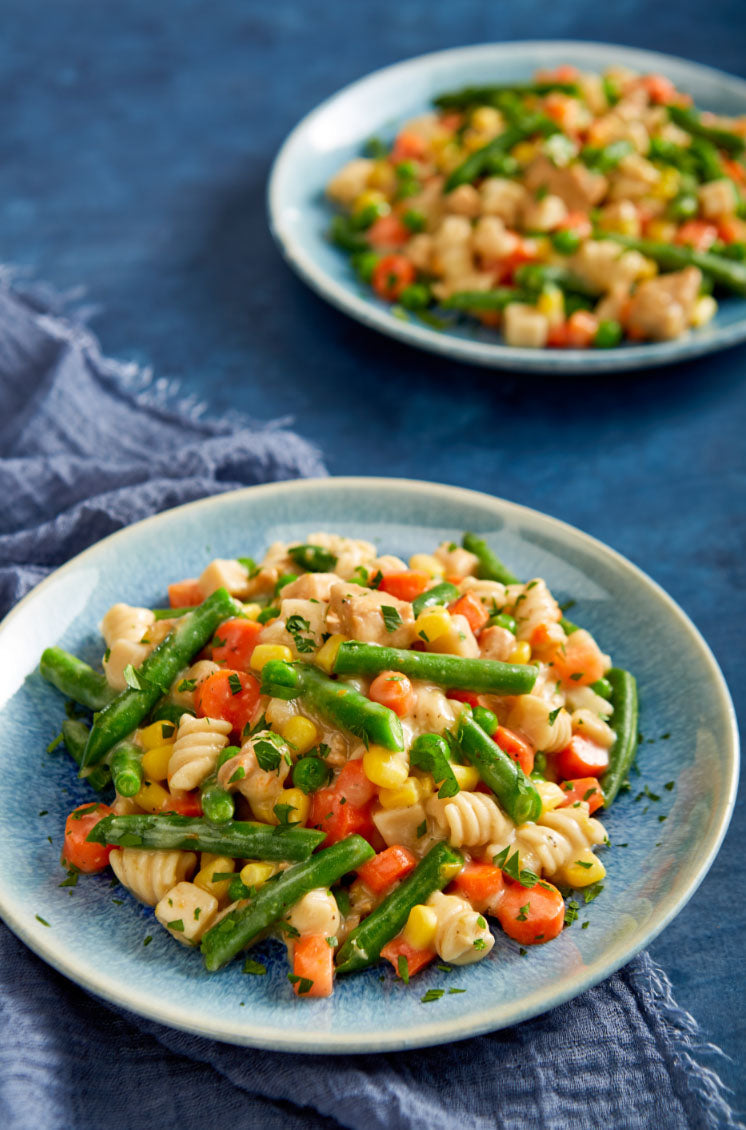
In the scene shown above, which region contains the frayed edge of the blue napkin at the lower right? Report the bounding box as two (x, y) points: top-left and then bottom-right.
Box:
(628, 953), (746, 1130)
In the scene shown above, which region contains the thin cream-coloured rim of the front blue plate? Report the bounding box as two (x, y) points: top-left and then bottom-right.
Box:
(0, 476), (739, 1054)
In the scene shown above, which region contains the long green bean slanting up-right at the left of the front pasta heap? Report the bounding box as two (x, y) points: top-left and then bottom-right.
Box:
(83, 589), (238, 767)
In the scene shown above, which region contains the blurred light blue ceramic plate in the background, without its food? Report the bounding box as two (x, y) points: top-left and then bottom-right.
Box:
(269, 41), (746, 374)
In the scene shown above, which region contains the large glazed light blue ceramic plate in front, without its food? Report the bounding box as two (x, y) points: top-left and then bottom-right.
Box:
(0, 479), (738, 1052)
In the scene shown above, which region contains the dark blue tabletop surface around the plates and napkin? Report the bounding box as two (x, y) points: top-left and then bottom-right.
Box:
(0, 0), (746, 1107)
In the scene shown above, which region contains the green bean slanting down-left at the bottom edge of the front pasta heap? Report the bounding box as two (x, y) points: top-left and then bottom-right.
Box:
(201, 828), (375, 972)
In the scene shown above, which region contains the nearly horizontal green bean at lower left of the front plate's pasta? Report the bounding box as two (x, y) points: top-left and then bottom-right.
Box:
(88, 812), (324, 860)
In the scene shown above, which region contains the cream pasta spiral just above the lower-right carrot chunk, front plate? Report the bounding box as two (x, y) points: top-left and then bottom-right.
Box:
(513, 802), (607, 877)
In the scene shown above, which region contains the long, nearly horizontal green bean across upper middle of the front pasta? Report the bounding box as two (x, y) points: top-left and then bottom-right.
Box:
(335, 640), (536, 695)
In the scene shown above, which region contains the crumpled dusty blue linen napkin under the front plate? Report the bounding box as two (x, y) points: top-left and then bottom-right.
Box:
(0, 279), (740, 1130)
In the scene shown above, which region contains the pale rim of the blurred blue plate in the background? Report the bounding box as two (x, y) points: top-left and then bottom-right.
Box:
(266, 40), (746, 377)
